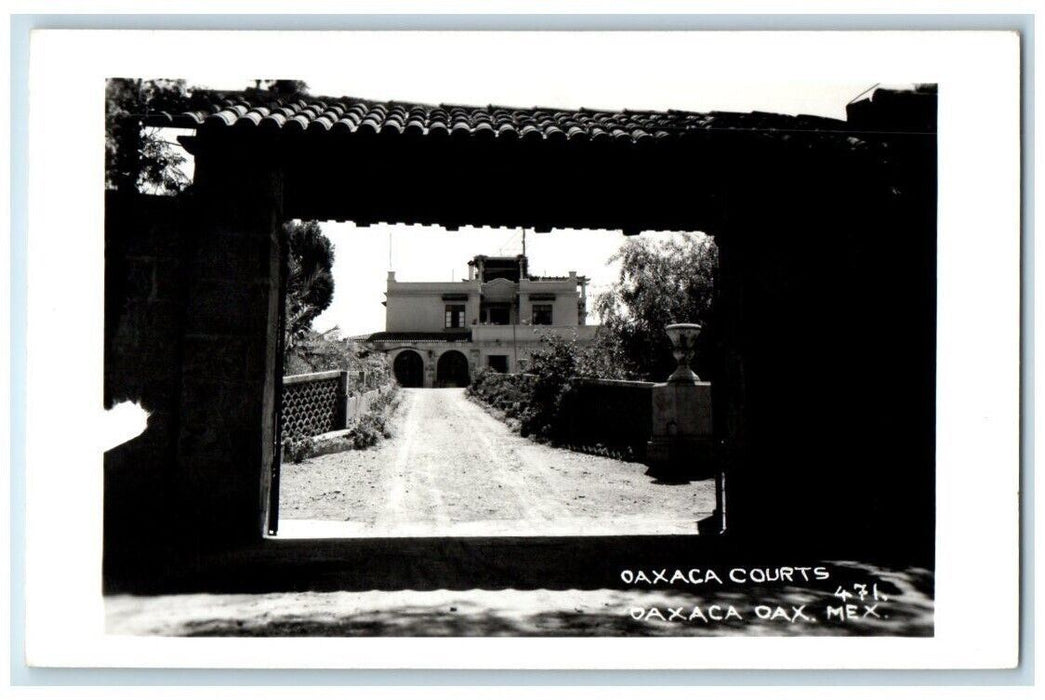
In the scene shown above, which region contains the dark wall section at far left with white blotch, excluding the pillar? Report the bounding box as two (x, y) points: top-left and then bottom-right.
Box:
(103, 193), (187, 558)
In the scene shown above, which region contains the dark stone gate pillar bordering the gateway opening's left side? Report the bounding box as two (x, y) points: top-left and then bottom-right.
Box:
(178, 136), (283, 550)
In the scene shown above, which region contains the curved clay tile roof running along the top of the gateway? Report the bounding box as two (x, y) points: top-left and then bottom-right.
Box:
(145, 91), (845, 144)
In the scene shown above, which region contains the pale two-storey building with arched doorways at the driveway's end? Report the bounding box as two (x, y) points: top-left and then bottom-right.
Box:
(368, 255), (598, 387)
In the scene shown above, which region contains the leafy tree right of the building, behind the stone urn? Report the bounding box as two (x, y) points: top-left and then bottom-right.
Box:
(593, 234), (718, 381)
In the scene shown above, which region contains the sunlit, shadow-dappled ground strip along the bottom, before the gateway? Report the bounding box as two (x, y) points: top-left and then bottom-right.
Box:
(106, 562), (933, 636)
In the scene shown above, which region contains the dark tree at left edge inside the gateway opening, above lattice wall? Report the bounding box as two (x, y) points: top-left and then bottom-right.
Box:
(283, 221), (333, 361)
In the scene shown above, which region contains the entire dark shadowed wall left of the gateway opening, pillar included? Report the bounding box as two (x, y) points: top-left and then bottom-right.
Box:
(103, 140), (283, 583)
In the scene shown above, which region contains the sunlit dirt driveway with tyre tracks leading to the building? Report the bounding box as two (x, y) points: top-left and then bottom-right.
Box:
(280, 389), (715, 537)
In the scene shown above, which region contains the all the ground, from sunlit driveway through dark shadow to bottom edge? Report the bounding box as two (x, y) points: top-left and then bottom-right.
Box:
(106, 390), (933, 636)
